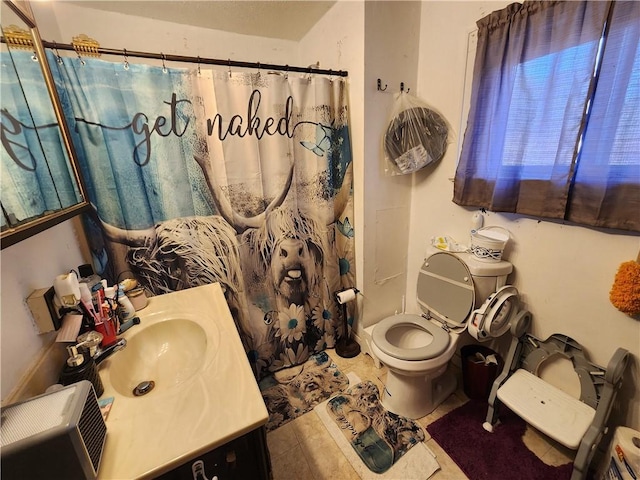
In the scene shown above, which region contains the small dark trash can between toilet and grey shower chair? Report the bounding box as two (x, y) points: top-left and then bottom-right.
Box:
(460, 345), (504, 400)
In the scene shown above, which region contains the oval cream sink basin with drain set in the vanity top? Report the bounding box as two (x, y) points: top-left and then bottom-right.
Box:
(109, 318), (215, 397)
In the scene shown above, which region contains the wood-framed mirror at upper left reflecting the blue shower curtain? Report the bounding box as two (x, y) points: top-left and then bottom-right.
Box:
(0, 0), (89, 248)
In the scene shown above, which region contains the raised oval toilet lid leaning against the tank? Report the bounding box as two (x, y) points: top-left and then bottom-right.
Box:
(417, 252), (475, 328)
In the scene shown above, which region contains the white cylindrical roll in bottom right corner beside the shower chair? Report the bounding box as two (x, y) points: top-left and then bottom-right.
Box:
(601, 427), (640, 480)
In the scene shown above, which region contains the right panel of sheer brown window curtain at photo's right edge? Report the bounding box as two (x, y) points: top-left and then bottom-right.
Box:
(568, 1), (640, 231)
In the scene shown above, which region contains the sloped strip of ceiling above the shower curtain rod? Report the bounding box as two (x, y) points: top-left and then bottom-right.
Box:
(62, 0), (336, 41)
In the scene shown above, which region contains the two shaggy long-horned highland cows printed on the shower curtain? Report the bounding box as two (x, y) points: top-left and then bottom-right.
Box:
(97, 157), (351, 376)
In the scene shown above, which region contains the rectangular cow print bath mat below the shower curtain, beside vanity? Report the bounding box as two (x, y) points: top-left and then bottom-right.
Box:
(259, 352), (349, 432)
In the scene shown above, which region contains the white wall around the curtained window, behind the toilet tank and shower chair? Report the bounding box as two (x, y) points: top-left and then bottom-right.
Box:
(407, 1), (640, 429)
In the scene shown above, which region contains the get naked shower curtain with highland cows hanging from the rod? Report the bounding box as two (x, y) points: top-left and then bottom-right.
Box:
(50, 55), (355, 378)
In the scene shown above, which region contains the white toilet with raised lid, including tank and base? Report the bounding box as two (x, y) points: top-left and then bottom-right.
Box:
(366, 251), (513, 419)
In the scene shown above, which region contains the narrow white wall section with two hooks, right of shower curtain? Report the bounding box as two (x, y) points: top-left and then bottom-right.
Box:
(357, 1), (421, 327)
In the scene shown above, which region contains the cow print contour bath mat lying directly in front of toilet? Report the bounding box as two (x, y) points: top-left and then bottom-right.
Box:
(327, 381), (425, 473)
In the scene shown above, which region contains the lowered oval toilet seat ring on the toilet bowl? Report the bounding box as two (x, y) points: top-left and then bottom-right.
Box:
(371, 314), (450, 360)
